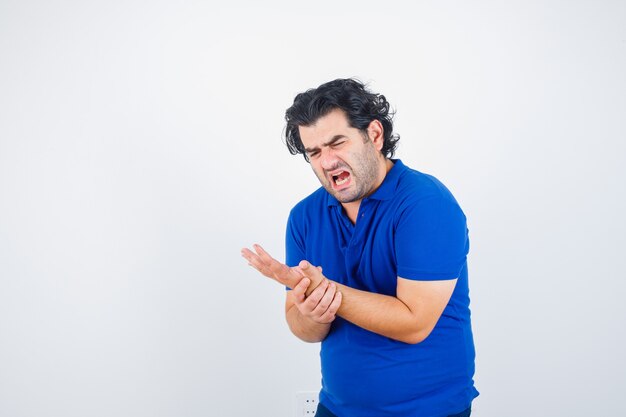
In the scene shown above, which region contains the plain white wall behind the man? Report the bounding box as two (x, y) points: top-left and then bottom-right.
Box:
(0, 0), (626, 417)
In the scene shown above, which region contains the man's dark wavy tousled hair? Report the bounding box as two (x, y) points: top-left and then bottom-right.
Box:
(285, 78), (400, 162)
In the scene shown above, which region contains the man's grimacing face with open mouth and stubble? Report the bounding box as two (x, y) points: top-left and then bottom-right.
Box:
(299, 109), (385, 203)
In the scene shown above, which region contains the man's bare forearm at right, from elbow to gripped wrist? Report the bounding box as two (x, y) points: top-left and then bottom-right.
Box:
(336, 284), (424, 344)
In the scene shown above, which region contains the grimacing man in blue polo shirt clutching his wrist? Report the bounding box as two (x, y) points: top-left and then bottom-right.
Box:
(242, 79), (478, 417)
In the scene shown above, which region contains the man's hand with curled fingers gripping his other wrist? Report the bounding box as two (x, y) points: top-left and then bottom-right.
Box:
(291, 278), (341, 324)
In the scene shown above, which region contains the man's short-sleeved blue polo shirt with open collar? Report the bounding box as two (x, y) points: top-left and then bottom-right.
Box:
(286, 160), (478, 417)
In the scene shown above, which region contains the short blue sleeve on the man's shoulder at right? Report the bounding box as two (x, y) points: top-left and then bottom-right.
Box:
(394, 195), (469, 281)
